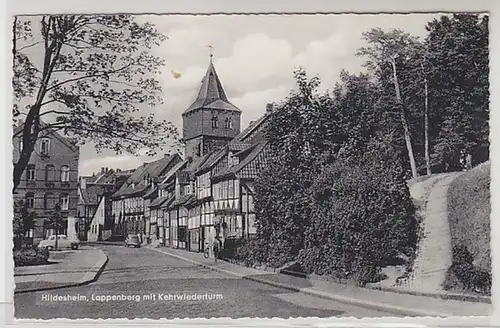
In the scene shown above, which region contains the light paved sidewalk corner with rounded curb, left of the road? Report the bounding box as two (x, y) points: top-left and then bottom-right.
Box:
(14, 246), (108, 293)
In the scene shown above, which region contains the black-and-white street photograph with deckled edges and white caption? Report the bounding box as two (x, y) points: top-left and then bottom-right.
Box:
(9, 12), (492, 320)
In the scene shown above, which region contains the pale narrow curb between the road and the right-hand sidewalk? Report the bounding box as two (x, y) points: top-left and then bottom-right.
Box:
(148, 248), (446, 317)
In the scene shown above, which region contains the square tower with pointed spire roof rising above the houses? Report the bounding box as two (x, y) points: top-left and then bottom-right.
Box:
(182, 54), (241, 158)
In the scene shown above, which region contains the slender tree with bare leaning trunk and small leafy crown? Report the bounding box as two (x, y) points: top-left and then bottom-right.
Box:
(357, 28), (419, 178)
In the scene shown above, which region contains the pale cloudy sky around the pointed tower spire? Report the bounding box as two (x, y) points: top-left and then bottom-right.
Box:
(63, 14), (437, 175)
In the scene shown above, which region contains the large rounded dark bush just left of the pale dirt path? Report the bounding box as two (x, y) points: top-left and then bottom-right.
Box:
(299, 139), (416, 284)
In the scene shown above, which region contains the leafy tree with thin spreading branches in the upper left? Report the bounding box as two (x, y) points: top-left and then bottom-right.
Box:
(12, 15), (177, 191)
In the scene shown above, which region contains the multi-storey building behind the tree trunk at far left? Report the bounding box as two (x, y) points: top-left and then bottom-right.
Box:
(13, 123), (80, 243)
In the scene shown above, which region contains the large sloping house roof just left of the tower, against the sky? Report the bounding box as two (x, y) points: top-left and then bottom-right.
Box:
(113, 154), (181, 197)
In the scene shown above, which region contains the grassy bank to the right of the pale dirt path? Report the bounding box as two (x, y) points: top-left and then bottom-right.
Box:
(448, 162), (491, 272)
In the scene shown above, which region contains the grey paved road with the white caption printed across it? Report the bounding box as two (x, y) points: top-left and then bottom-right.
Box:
(14, 246), (394, 319)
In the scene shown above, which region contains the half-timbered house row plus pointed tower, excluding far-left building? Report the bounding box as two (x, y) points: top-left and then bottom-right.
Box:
(78, 57), (272, 251)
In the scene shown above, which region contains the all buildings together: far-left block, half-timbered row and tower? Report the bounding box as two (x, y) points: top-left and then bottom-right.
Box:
(13, 58), (272, 251)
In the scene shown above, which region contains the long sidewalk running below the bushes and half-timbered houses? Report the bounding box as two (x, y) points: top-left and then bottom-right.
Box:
(150, 247), (492, 317)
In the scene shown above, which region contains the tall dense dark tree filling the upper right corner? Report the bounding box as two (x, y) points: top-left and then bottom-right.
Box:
(426, 14), (489, 170)
